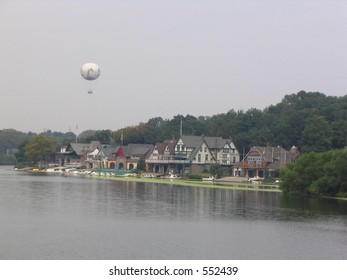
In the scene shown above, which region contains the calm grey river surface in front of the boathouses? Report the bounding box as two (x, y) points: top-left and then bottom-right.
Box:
(0, 167), (347, 260)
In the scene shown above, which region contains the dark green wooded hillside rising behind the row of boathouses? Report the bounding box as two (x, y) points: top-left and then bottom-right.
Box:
(0, 91), (347, 163)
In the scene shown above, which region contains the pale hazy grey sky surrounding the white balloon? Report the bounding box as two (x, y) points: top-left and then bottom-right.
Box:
(0, 0), (347, 133)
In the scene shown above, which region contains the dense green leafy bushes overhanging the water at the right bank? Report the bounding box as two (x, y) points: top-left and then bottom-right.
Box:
(281, 150), (347, 197)
